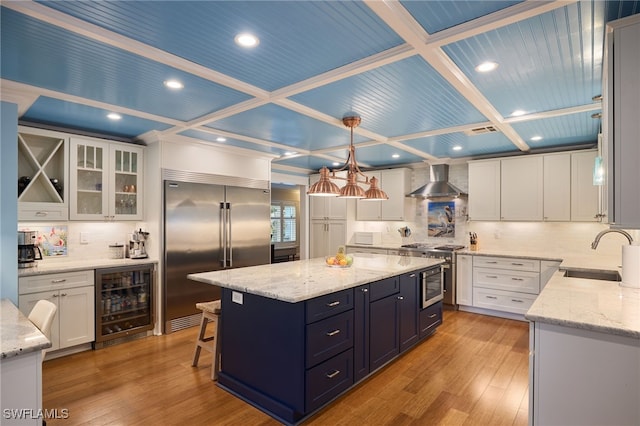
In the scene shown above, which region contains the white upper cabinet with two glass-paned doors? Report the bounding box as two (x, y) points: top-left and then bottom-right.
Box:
(70, 137), (144, 220)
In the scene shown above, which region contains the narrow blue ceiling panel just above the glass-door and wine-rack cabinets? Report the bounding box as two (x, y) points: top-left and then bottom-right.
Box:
(21, 96), (171, 139)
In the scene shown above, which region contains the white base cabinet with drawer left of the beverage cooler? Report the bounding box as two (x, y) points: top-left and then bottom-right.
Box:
(18, 270), (95, 350)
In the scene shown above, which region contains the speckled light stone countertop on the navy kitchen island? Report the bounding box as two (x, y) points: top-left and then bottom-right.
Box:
(188, 253), (442, 303)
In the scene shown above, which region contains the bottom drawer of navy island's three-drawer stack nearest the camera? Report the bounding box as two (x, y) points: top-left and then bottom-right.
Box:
(305, 349), (353, 413)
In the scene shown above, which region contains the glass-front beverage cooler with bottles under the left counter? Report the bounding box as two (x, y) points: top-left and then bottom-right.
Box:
(95, 264), (156, 347)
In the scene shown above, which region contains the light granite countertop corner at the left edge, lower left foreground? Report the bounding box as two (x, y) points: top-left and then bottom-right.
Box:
(0, 299), (51, 359)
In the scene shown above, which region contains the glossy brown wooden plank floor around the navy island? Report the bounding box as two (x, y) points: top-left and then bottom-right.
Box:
(43, 311), (529, 426)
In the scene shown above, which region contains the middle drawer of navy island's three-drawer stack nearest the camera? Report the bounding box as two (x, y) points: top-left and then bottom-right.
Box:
(306, 310), (353, 368)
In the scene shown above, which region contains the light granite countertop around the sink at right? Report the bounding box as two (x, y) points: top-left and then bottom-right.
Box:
(525, 271), (640, 339)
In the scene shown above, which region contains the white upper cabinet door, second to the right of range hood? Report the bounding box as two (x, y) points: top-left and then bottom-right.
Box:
(500, 157), (543, 220)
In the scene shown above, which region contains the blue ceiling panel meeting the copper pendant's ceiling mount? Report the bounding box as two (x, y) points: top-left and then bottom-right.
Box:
(292, 56), (486, 137)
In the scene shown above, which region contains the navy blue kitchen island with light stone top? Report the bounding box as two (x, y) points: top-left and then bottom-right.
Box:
(189, 254), (442, 424)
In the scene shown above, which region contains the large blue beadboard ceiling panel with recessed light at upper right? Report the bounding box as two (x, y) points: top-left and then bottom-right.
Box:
(444, 1), (605, 117)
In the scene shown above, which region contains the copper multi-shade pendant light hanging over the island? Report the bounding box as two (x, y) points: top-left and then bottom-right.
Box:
(307, 116), (389, 200)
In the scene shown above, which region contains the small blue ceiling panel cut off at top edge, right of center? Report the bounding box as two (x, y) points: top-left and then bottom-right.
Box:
(400, 0), (521, 34)
